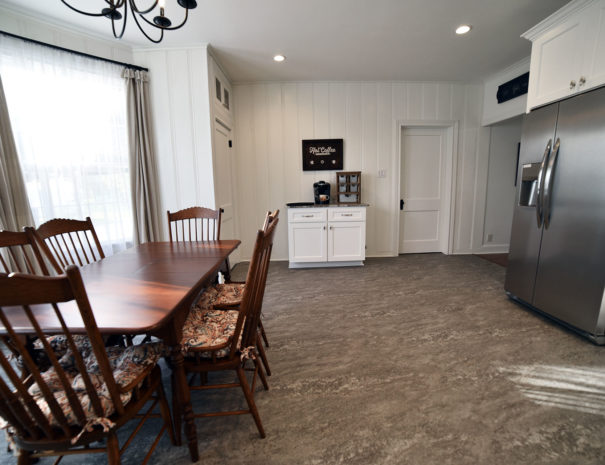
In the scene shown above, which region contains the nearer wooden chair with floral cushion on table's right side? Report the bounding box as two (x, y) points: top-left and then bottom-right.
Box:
(173, 219), (278, 438)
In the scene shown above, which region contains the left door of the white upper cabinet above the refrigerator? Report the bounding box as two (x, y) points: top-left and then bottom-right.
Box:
(527, 11), (590, 108)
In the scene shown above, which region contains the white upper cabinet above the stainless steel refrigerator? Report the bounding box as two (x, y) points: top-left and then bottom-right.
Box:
(523, 0), (605, 111)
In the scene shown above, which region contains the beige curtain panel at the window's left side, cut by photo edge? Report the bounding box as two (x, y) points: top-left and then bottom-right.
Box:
(0, 76), (34, 231)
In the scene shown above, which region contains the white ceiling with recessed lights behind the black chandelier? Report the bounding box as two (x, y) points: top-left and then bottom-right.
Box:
(0, 0), (568, 82)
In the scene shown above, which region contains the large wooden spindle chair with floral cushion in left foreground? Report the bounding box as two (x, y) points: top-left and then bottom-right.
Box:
(0, 265), (174, 465)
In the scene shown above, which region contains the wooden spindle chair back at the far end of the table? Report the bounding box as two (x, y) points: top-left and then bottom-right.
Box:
(166, 207), (221, 242)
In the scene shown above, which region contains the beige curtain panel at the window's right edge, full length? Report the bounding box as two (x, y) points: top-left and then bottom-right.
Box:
(122, 68), (163, 244)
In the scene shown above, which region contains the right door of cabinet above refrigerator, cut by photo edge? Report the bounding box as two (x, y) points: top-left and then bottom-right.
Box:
(580, 0), (605, 90)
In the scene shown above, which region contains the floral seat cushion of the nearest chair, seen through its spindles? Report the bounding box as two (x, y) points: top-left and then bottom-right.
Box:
(28, 340), (164, 426)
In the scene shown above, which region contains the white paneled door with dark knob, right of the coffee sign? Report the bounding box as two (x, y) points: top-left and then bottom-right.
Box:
(399, 128), (451, 253)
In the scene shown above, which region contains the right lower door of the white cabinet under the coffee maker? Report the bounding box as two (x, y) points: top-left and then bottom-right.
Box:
(328, 221), (366, 262)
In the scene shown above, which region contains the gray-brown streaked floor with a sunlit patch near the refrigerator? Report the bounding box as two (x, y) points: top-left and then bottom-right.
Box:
(0, 254), (605, 465)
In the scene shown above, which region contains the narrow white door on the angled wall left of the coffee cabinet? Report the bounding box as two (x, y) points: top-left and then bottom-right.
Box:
(214, 121), (239, 260)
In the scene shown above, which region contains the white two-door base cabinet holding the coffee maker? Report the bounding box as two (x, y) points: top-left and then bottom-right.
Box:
(288, 206), (366, 268)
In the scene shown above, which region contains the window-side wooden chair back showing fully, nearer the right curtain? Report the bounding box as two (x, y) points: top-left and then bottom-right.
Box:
(34, 217), (105, 274)
